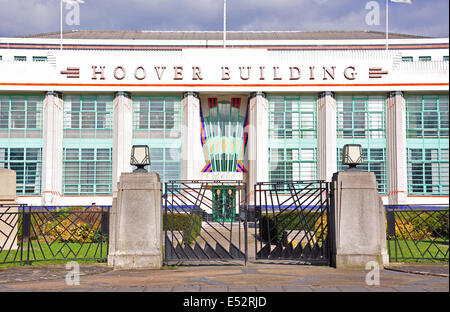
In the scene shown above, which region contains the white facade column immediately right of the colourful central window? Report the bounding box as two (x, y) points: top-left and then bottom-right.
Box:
(247, 92), (269, 205)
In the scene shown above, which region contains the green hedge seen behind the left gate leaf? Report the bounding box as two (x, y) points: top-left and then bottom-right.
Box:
(163, 212), (202, 245)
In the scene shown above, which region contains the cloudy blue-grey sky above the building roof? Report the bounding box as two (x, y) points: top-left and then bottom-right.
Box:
(0, 0), (449, 37)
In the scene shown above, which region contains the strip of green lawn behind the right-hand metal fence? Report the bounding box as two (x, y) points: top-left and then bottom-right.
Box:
(388, 240), (448, 263)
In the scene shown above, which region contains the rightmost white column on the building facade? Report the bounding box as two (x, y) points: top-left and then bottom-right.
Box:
(386, 91), (408, 205)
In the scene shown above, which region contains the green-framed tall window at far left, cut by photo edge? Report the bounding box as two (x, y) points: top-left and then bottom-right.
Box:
(0, 95), (43, 195)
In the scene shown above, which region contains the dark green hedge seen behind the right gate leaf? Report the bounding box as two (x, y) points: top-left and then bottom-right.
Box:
(259, 212), (326, 244)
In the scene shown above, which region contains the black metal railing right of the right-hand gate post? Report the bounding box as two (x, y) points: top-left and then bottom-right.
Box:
(385, 205), (449, 262)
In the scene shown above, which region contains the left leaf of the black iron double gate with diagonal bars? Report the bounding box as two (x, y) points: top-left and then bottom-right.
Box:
(163, 181), (247, 265)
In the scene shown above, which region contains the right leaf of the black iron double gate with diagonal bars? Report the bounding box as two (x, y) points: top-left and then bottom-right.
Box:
(254, 181), (330, 264)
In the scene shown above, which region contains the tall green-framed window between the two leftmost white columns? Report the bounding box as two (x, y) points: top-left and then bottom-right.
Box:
(63, 95), (113, 195)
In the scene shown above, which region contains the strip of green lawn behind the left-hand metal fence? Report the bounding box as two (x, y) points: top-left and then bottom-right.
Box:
(0, 242), (108, 268)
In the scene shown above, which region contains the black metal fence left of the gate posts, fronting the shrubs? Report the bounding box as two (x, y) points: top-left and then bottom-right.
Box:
(0, 204), (110, 265)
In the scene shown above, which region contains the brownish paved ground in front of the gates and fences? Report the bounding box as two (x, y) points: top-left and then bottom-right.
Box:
(0, 263), (449, 292)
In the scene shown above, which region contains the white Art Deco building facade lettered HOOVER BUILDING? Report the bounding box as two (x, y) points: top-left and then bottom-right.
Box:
(0, 33), (449, 205)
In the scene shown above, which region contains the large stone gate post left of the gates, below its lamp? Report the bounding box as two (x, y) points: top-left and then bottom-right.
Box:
(108, 172), (163, 269)
